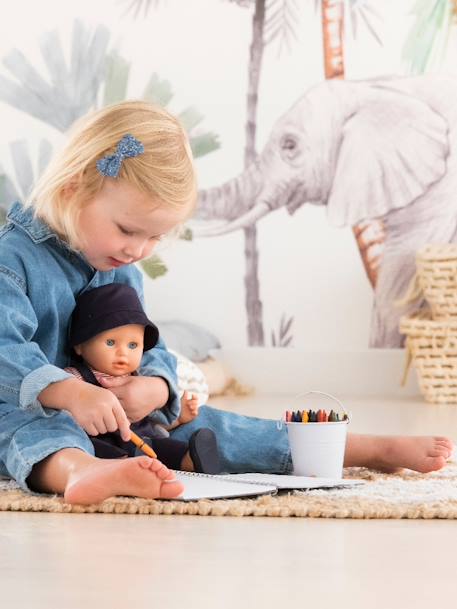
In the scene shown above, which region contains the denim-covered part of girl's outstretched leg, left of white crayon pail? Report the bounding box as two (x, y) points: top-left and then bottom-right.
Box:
(170, 406), (292, 474)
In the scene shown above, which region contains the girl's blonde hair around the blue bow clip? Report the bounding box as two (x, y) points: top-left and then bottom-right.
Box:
(26, 101), (197, 248)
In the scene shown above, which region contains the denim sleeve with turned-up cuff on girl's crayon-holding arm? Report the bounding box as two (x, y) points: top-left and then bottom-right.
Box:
(0, 266), (72, 416)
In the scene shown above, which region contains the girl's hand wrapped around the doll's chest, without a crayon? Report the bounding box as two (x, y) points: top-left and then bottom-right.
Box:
(100, 376), (169, 423)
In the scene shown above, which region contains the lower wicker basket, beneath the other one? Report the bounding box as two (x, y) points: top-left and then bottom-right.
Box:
(400, 312), (457, 404)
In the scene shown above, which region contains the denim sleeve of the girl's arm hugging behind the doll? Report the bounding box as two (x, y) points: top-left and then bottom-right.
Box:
(116, 267), (181, 425)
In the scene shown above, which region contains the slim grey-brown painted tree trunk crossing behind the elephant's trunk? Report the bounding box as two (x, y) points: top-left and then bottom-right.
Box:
(243, 0), (265, 346)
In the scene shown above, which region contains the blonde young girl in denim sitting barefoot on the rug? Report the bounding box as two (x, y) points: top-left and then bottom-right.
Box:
(0, 102), (452, 504)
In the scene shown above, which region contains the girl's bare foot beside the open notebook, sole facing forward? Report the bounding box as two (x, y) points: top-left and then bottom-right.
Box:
(64, 456), (184, 505)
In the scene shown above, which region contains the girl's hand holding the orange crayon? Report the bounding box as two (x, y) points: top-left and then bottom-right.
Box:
(38, 379), (130, 441)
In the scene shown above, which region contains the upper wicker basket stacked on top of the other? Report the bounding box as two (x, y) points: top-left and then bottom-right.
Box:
(416, 243), (457, 319)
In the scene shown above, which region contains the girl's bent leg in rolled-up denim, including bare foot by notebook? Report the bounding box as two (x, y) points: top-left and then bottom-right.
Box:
(0, 404), (183, 503)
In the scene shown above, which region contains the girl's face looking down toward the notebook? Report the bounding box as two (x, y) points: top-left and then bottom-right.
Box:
(78, 178), (186, 271)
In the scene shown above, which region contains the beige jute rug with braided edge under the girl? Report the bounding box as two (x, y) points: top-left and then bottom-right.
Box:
(0, 463), (457, 519)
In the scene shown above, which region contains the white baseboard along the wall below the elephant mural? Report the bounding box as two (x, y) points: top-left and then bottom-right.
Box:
(211, 347), (420, 397)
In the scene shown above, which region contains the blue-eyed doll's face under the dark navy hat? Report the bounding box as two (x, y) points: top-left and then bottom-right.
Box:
(75, 324), (144, 376)
